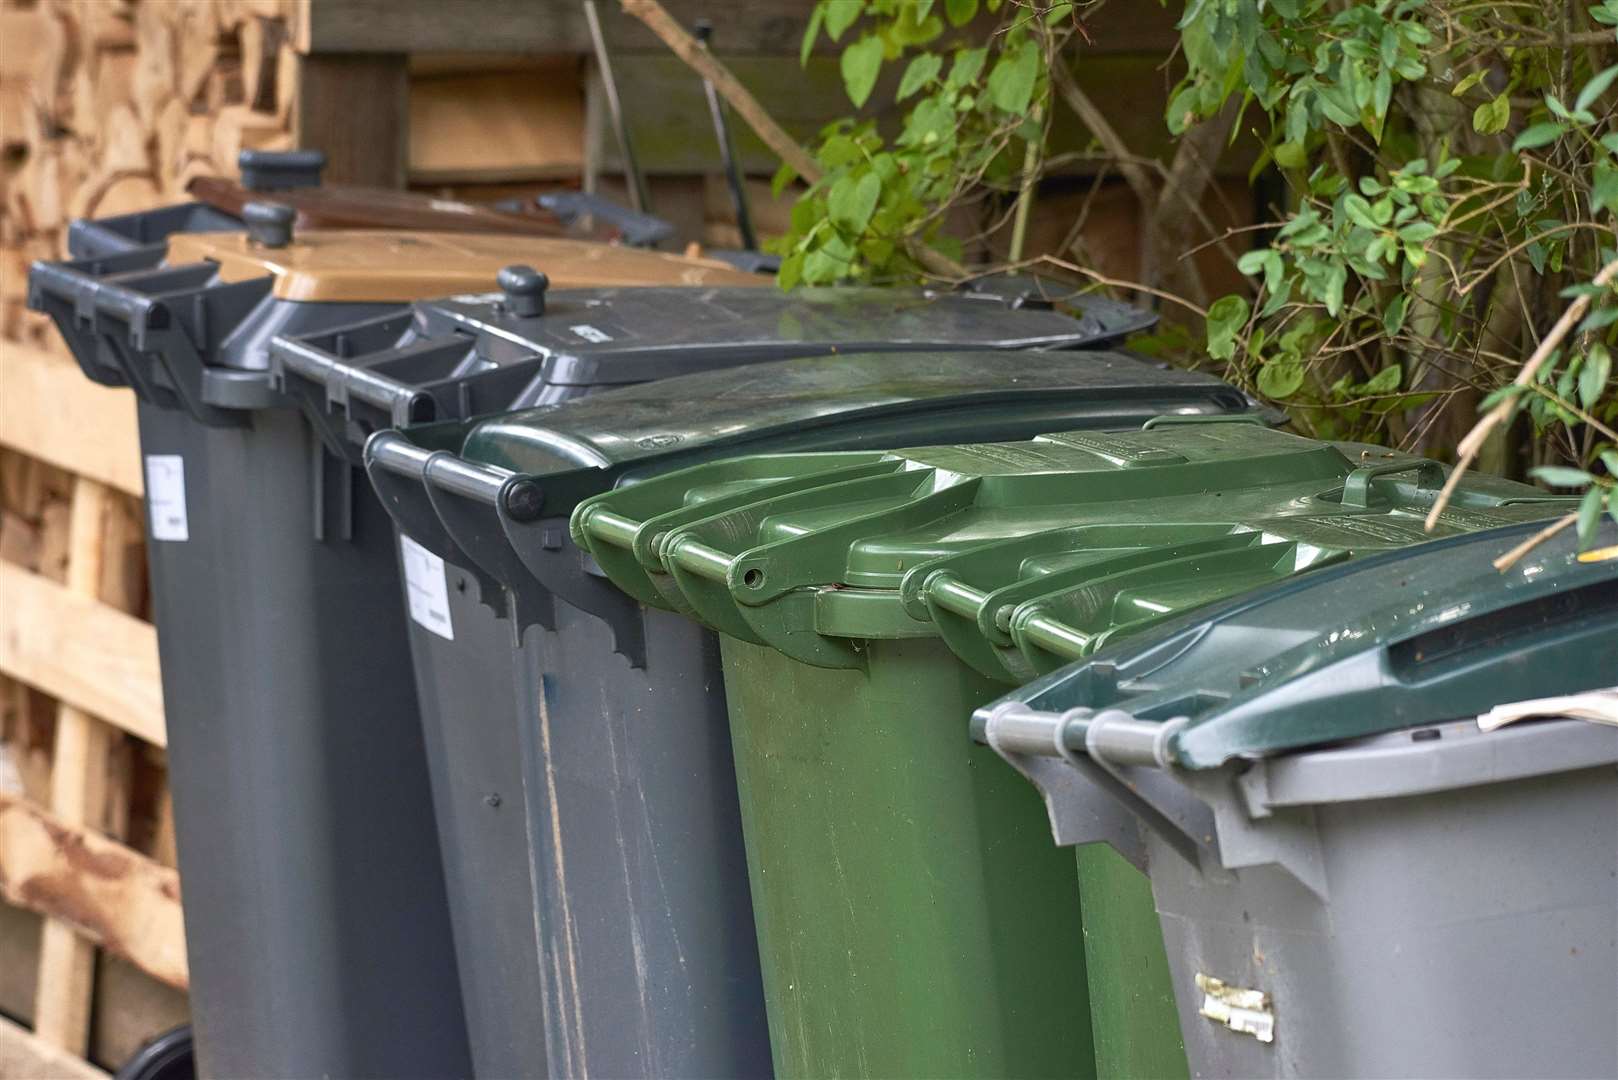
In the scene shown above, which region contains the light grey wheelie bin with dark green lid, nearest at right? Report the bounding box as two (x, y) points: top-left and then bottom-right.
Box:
(972, 525), (1618, 1077)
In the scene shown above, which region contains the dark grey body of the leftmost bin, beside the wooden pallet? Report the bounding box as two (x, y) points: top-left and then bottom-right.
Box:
(139, 403), (468, 1077)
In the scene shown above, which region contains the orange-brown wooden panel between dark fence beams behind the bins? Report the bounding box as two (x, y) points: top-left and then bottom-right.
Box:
(409, 57), (584, 185)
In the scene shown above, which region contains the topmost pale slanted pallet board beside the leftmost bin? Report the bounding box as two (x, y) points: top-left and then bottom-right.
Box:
(0, 342), (142, 495)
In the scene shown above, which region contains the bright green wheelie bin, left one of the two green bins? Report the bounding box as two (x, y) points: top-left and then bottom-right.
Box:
(571, 419), (1550, 1077)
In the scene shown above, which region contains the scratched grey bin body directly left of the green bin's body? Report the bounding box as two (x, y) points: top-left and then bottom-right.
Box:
(513, 604), (770, 1077)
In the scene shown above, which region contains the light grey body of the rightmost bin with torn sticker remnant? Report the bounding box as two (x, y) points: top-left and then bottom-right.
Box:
(1149, 738), (1618, 1078)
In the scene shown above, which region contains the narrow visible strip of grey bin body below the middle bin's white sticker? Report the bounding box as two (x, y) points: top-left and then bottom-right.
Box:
(404, 563), (545, 1077)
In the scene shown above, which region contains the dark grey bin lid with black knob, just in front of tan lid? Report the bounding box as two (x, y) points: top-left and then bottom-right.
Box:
(270, 278), (1155, 447)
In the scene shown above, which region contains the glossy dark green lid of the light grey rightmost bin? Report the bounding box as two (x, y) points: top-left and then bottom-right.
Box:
(972, 525), (1618, 769)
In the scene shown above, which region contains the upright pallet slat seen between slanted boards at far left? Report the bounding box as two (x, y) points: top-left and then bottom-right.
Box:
(34, 476), (113, 1057)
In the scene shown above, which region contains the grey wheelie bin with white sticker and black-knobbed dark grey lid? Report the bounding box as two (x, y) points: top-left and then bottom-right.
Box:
(272, 283), (1190, 1075)
